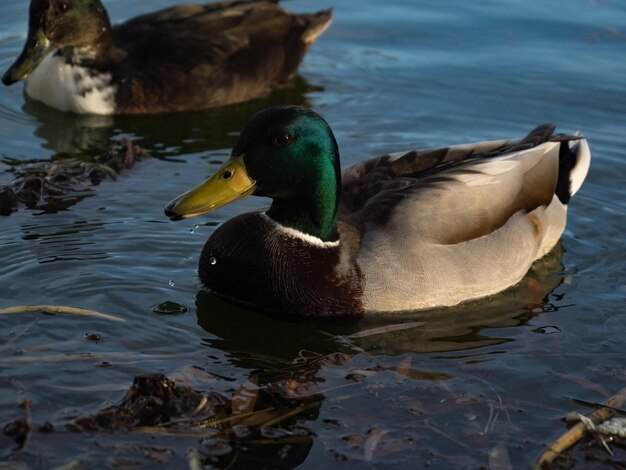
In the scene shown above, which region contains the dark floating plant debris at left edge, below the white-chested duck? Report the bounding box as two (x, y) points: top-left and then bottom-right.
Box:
(0, 138), (148, 216)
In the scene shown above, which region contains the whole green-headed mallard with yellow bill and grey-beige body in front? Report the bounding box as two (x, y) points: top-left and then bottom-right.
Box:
(165, 106), (590, 316)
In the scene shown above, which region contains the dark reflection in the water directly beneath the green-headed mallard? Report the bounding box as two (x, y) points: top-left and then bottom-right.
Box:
(196, 242), (565, 368)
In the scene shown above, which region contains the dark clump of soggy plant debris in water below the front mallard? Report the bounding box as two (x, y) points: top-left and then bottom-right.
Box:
(26, 373), (322, 468)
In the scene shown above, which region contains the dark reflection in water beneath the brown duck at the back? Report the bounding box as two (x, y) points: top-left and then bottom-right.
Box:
(22, 76), (321, 157)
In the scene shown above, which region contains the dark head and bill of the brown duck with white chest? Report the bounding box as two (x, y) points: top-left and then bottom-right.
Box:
(2, 0), (111, 85)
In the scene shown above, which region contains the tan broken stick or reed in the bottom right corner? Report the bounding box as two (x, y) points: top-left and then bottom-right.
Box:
(533, 388), (626, 470)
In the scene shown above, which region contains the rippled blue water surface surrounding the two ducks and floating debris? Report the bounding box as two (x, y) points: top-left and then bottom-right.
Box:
(0, 0), (626, 469)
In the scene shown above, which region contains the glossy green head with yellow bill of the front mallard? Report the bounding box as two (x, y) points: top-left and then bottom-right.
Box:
(165, 106), (341, 241)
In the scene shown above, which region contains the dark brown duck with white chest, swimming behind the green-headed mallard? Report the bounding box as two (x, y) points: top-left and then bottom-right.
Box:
(2, 0), (331, 114)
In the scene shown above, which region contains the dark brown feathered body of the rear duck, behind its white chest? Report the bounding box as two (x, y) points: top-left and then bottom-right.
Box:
(113, 1), (331, 111)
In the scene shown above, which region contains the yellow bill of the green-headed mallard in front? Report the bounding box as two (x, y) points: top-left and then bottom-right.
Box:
(165, 155), (256, 220)
